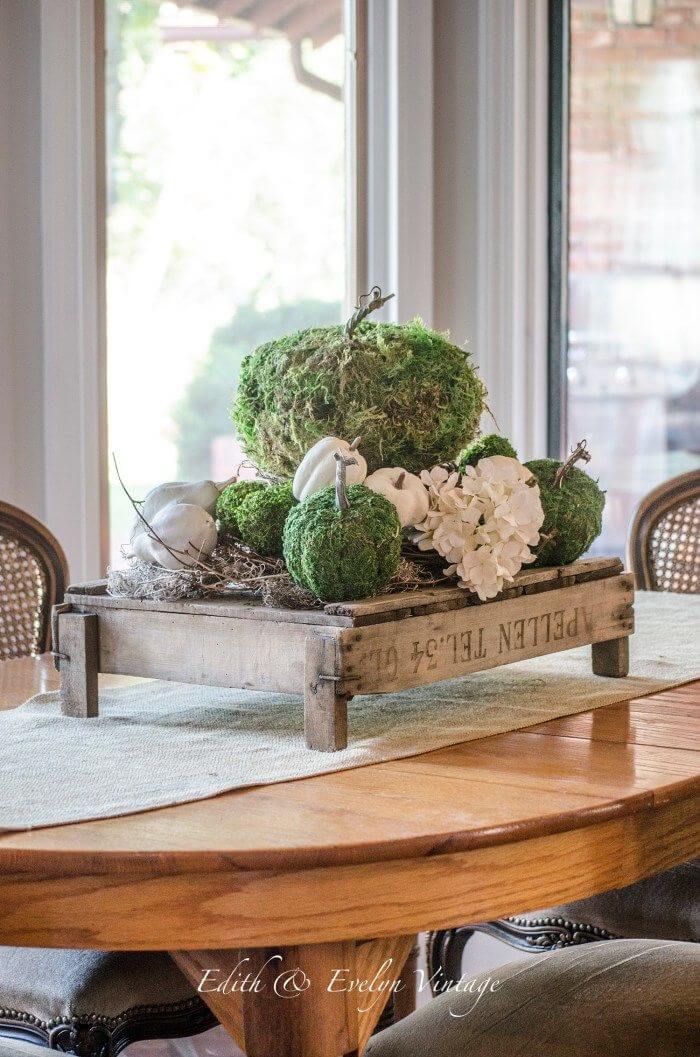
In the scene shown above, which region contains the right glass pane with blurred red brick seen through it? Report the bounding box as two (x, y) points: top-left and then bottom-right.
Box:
(567, 0), (700, 554)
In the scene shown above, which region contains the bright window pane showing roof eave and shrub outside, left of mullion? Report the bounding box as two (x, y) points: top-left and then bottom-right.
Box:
(107, 0), (345, 562)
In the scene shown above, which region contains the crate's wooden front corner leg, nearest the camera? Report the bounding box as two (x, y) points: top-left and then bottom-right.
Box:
(303, 636), (350, 753)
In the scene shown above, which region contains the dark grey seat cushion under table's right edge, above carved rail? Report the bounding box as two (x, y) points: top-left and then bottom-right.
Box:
(515, 859), (700, 942)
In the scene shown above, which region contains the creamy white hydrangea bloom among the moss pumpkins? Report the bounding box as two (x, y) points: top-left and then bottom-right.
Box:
(413, 456), (545, 601)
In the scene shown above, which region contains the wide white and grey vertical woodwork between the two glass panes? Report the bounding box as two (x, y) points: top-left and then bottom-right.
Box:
(366, 0), (549, 458)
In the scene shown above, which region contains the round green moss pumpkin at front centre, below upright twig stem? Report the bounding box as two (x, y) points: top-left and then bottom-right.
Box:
(284, 484), (401, 601)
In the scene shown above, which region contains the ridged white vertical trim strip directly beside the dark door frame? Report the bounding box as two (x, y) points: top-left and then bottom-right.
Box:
(476, 0), (549, 458)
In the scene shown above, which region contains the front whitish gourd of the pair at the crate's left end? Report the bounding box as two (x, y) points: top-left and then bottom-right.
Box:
(131, 500), (217, 570)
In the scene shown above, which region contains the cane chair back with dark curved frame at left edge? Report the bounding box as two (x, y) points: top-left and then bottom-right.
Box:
(0, 502), (68, 661)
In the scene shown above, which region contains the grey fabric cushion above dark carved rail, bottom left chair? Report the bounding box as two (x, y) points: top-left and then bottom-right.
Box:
(0, 947), (206, 1027)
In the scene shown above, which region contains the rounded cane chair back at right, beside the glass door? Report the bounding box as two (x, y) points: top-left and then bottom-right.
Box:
(627, 469), (700, 594)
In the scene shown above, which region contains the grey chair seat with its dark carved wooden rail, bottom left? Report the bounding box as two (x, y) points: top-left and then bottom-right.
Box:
(0, 947), (217, 1057)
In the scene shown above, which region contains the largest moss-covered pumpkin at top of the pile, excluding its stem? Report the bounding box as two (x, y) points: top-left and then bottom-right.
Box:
(232, 319), (485, 477)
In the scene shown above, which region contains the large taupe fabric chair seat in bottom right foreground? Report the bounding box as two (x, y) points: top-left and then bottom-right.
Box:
(365, 940), (700, 1057)
